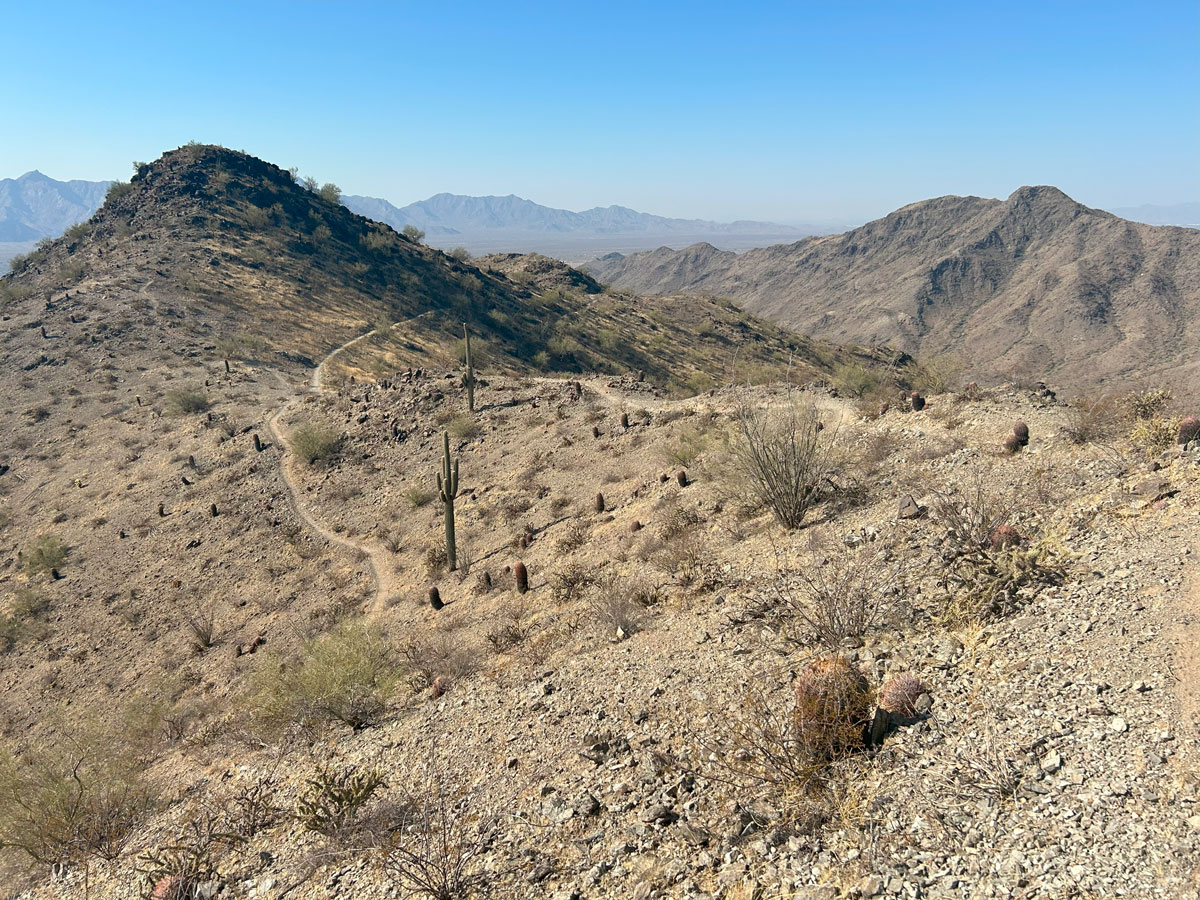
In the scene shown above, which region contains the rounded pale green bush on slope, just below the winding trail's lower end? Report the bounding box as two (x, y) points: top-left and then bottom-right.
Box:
(250, 622), (396, 731)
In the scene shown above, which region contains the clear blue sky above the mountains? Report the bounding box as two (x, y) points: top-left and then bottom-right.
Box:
(0, 0), (1200, 223)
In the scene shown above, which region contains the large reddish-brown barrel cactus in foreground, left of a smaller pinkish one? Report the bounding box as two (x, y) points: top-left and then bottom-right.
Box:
(792, 655), (871, 757)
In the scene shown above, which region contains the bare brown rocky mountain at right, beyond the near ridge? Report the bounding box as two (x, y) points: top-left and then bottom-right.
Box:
(587, 187), (1200, 388)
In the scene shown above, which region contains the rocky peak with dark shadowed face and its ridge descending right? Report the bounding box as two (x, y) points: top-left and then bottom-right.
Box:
(0, 145), (883, 390)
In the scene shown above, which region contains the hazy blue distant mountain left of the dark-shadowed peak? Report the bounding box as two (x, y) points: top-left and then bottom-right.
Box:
(0, 172), (112, 242)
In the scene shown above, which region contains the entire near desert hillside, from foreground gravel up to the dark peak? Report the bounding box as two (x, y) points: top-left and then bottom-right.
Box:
(0, 146), (1200, 900)
